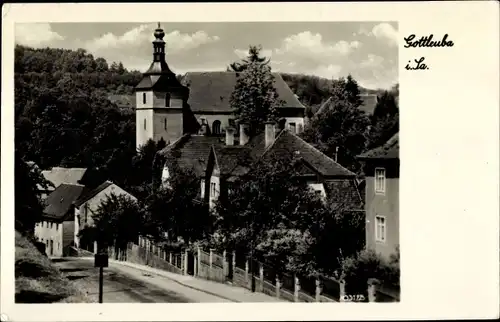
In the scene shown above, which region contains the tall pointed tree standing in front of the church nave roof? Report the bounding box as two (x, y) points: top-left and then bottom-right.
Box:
(230, 62), (284, 135)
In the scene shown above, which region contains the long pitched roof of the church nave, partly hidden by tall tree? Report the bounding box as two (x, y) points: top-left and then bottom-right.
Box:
(181, 72), (305, 113)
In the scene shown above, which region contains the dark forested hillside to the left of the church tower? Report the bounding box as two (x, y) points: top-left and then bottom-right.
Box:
(15, 46), (146, 191)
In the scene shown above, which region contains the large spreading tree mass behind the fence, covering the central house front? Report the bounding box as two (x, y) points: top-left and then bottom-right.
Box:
(210, 156), (356, 275)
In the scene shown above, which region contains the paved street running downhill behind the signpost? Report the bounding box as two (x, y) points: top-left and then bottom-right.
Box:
(54, 258), (231, 303)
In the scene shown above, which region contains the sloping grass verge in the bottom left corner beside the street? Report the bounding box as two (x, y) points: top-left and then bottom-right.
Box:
(15, 231), (95, 303)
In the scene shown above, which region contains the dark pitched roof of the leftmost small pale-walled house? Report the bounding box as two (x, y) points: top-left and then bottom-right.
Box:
(43, 183), (85, 221)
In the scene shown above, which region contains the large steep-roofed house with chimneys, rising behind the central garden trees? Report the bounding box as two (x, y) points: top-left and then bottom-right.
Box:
(201, 122), (363, 211)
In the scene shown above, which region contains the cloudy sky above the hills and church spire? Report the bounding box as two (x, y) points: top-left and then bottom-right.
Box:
(15, 22), (398, 89)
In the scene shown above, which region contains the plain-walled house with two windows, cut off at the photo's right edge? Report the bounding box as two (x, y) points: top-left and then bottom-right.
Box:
(359, 133), (399, 258)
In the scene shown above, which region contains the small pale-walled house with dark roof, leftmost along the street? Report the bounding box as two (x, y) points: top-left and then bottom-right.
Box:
(35, 183), (85, 257)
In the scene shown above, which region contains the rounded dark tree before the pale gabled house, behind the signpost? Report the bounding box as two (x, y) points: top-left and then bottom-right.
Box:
(93, 194), (144, 253)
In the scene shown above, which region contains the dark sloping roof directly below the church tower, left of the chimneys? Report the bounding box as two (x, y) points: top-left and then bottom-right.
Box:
(158, 134), (225, 177)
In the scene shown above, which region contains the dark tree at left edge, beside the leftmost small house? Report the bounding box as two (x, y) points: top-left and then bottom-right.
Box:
(14, 151), (53, 235)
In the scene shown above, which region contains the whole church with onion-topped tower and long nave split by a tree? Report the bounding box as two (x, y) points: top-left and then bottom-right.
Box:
(129, 26), (305, 152)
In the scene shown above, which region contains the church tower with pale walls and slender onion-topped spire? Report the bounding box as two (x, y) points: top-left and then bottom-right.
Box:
(135, 23), (189, 148)
